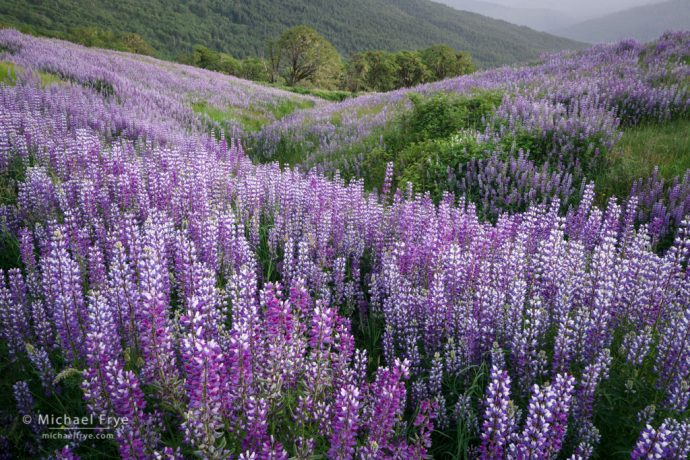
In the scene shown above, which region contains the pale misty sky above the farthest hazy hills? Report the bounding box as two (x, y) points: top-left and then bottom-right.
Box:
(487, 0), (662, 17)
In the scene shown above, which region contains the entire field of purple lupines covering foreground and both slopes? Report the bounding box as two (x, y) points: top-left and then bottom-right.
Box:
(0, 30), (690, 459)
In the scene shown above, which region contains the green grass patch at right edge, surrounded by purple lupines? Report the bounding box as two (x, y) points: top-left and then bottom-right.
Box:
(595, 119), (690, 197)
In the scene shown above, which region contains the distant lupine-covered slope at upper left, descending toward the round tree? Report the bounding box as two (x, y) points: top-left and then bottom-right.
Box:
(0, 29), (319, 140)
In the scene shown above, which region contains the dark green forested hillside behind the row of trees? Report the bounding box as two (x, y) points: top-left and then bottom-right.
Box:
(0, 0), (578, 67)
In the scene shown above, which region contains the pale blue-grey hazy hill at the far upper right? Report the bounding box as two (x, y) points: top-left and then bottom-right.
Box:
(559, 0), (690, 43)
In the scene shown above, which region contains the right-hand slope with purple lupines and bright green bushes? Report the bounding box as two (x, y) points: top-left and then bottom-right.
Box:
(255, 33), (690, 244)
